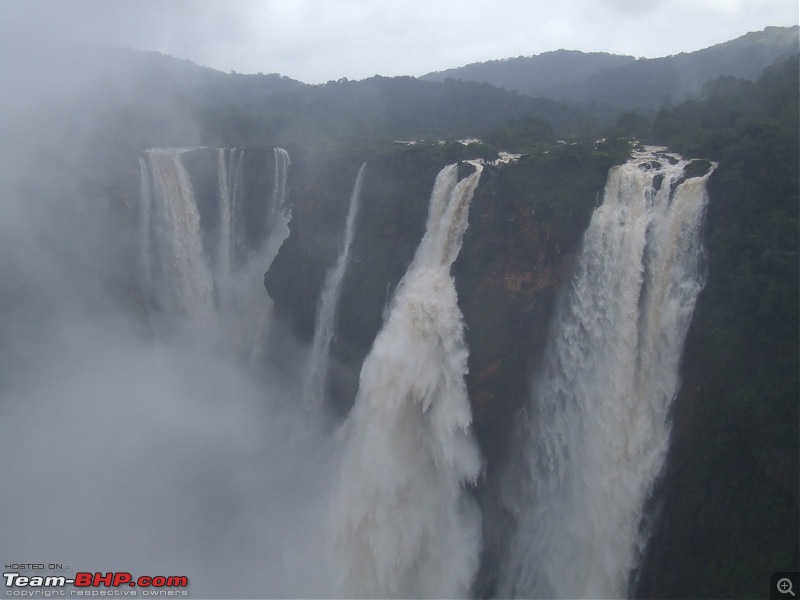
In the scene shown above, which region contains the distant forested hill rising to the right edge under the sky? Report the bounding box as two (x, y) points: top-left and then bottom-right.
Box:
(422, 26), (798, 109)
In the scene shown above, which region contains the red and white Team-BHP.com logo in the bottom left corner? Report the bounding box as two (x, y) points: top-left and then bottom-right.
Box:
(3, 571), (189, 598)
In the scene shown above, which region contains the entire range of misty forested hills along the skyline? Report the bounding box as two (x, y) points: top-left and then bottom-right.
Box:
(6, 27), (798, 151)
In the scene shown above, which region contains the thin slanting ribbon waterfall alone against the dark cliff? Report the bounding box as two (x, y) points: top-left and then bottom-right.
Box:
(303, 163), (367, 407)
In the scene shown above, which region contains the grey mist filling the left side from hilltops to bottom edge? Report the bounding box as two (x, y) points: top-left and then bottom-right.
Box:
(0, 41), (335, 597)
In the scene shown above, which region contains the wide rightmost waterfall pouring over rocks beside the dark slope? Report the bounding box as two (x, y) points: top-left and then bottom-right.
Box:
(500, 152), (708, 598)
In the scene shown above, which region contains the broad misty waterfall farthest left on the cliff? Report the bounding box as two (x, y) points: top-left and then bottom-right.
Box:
(140, 149), (213, 315)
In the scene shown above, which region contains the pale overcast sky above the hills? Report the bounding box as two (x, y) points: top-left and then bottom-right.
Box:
(0, 0), (798, 83)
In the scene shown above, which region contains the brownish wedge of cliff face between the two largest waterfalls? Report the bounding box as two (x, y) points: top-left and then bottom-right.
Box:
(453, 146), (613, 466)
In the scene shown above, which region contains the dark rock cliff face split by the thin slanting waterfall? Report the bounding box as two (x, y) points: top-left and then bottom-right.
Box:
(264, 148), (460, 412)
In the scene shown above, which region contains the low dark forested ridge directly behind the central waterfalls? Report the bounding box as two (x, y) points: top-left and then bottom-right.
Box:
(200, 76), (593, 143)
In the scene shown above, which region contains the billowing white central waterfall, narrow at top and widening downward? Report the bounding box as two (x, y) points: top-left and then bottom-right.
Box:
(331, 163), (482, 598)
